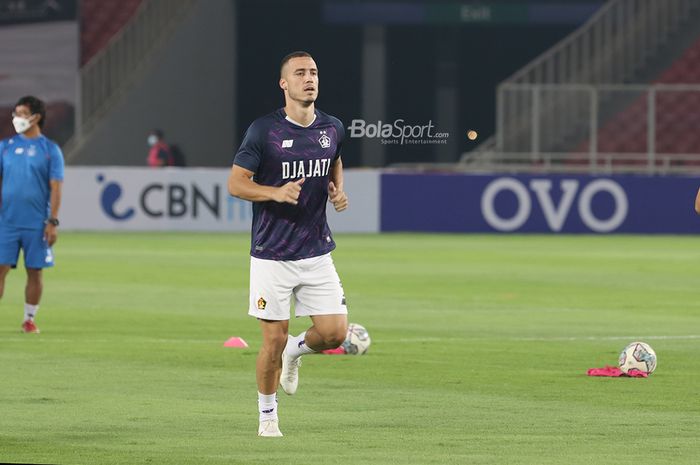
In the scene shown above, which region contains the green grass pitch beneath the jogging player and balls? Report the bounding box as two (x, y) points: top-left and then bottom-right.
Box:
(0, 232), (700, 465)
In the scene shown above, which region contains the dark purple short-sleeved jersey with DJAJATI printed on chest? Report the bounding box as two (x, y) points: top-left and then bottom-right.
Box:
(233, 109), (345, 260)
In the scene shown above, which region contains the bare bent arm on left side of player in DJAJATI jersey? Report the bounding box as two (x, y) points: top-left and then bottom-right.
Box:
(228, 165), (304, 205)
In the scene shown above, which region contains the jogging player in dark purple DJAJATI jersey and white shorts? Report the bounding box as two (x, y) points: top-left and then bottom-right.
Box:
(228, 52), (348, 437)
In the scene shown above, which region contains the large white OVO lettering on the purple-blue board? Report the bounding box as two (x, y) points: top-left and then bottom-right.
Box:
(481, 178), (629, 233)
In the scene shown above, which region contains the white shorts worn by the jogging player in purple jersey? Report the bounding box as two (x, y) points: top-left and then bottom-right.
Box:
(248, 253), (348, 320)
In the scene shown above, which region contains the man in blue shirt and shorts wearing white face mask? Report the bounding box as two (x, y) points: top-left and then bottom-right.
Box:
(0, 96), (63, 333)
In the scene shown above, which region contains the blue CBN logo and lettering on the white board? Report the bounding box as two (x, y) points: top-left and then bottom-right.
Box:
(97, 174), (252, 222)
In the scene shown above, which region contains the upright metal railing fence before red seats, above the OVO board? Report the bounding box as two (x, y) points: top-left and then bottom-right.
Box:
(460, 84), (700, 173)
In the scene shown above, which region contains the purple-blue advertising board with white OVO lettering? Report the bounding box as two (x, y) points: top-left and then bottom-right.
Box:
(381, 173), (700, 234)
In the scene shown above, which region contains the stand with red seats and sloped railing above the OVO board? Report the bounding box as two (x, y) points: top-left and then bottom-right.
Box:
(459, 0), (700, 173)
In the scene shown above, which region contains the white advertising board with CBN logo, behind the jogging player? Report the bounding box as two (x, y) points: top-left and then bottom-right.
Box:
(60, 167), (379, 232)
